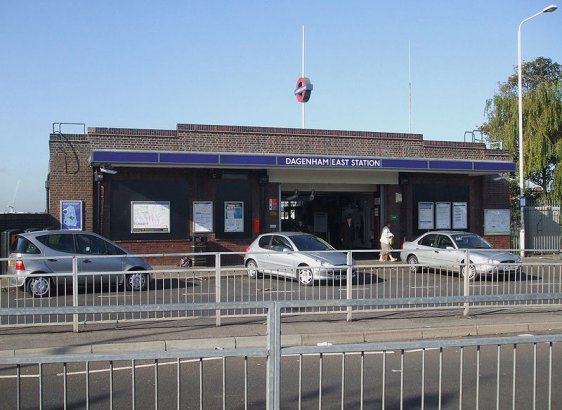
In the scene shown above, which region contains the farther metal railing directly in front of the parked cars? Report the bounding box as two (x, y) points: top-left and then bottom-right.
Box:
(0, 249), (562, 330)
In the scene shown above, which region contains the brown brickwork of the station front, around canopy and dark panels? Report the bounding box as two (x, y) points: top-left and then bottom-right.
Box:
(49, 124), (511, 253)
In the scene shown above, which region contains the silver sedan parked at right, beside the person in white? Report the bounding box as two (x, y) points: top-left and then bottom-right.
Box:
(400, 231), (521, 280)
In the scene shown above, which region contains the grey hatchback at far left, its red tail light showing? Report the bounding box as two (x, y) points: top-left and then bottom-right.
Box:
(7, 230), (152, 297)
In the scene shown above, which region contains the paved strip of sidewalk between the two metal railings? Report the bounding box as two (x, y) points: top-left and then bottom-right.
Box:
(0, 258), (562, 357)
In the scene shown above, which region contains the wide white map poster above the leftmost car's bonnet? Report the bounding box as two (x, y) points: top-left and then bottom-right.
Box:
(131, 201), (170, 233)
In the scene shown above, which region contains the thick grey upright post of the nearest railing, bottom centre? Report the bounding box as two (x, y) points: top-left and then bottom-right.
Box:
(266, 302), (281, 410)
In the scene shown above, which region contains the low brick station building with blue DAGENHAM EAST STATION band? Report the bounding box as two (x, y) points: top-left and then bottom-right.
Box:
(47, 124), (515, 253)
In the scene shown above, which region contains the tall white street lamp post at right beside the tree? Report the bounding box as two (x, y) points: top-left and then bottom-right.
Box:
(517, 4), (558, 256)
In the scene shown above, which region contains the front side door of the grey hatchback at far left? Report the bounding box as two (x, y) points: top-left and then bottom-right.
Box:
(76, 233), (123, 283)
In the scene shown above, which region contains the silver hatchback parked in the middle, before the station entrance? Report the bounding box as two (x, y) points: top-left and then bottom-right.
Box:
(244, 232), (355, 285)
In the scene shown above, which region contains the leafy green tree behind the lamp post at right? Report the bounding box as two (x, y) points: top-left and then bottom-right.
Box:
(480, 57), (562, 198)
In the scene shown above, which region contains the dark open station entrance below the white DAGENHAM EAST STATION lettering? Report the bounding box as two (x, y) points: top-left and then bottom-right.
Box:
(280, 189), (380, 249)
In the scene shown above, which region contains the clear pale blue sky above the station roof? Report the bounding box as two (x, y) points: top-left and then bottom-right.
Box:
(0, 0), (562, 212)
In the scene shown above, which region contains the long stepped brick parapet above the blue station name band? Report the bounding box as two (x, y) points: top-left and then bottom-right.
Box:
(84, 124), (510, 161)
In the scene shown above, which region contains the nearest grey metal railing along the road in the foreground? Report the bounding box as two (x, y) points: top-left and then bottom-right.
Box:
(0, 296), (562, 409)
